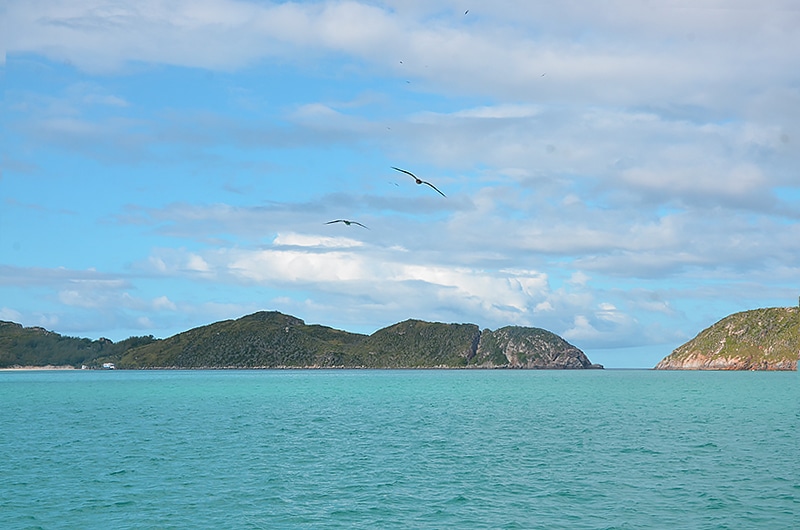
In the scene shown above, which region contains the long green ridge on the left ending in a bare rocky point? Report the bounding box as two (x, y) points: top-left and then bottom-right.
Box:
(0, 311), (600, 369)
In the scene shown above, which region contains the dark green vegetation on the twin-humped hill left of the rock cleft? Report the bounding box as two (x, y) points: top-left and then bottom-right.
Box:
(119, 312), (480, 368)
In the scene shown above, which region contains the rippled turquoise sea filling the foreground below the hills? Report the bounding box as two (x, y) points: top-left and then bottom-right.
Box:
(0, 370), (800, 529)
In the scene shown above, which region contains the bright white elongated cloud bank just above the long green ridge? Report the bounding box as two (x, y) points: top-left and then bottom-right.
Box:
(139, 234), (549, 322)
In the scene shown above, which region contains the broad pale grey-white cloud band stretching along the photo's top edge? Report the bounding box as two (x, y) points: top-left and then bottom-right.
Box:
(4, 0), (800, 106)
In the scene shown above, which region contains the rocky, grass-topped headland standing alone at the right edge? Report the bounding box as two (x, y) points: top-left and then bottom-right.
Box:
(655, 307), (800, 370)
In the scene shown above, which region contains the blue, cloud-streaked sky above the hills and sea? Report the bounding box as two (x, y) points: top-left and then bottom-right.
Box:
(0, 0), (800, 368)
